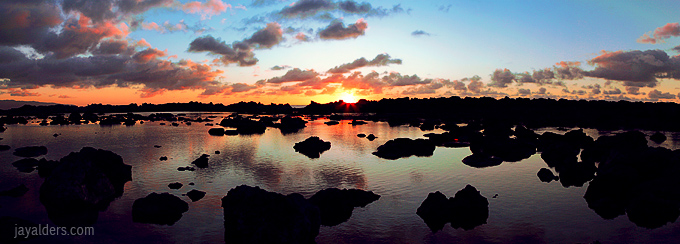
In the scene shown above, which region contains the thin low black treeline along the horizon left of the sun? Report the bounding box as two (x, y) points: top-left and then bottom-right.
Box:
(0, 102), (293, 117)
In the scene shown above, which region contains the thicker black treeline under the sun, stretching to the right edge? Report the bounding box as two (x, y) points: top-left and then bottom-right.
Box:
(300, 96), (680, 131)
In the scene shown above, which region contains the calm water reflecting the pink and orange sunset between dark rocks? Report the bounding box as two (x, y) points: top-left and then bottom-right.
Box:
(0, 114), (680, 243)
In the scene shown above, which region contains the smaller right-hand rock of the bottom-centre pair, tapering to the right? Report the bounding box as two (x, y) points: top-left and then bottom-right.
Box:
(309, 188), (380, 226)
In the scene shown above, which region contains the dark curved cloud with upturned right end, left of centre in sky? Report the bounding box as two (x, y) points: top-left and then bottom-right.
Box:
(188, 22), (283, 66)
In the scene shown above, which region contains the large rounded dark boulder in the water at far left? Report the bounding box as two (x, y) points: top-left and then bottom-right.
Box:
(40, 147), (132, 226)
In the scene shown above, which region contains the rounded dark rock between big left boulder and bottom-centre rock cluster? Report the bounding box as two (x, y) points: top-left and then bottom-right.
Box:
(132, 192), (189, 225)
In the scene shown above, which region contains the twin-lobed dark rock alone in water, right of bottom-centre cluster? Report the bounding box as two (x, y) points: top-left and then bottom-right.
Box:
(416, 185), (489, 233)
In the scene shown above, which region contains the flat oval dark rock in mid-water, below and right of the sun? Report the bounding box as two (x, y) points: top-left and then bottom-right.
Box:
(373, 138), (435, 160)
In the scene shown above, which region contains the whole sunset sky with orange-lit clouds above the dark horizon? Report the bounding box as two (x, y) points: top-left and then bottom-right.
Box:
(0, 0), (680, 105)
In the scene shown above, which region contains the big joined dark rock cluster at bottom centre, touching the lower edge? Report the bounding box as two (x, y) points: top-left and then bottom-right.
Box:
(222, 185), (380, 243)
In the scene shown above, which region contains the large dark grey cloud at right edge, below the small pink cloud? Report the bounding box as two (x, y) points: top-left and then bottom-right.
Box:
(585, 50), (680, 87)
